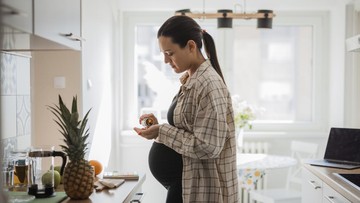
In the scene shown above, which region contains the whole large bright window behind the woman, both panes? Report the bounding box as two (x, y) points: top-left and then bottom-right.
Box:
(122, 12), (327, 131)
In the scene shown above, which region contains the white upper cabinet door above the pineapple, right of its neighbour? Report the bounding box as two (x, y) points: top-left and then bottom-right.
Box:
(34, 0), (81, 50)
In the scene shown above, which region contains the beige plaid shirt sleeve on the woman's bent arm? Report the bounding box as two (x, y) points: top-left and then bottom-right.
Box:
(157, 86), (229, 159)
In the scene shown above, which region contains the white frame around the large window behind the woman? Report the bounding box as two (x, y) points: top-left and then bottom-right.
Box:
(119, 11), (329, 134)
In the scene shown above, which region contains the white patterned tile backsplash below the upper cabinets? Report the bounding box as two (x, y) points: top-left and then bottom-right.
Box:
(0, 52), (31, 161)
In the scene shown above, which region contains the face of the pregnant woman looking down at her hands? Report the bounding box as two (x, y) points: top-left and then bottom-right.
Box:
(159, 36), (192, 73)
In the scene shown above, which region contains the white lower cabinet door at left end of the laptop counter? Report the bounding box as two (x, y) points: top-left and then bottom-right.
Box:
(301, 168), (323, 203)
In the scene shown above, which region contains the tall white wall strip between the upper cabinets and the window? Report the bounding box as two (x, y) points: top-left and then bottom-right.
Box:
(82, 0), (117, 166)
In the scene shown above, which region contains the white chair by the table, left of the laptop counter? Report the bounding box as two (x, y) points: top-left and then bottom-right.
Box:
(249, 141), (318, 203)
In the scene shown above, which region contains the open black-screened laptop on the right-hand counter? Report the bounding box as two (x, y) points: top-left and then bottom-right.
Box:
(309, 128), (360, 169)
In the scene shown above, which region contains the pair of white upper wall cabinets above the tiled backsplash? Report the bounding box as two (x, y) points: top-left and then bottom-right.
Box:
(1, 0), (82, 51)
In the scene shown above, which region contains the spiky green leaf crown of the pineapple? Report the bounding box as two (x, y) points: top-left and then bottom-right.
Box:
(48, 95), (91, 162)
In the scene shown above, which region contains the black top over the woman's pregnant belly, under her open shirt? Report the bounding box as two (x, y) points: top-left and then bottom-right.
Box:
(149, 95), (183, 188)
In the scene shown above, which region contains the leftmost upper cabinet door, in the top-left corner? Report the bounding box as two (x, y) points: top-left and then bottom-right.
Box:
(1, 0), (33, 33)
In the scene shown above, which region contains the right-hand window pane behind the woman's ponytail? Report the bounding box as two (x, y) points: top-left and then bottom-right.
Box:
(230, 25), (313, 122)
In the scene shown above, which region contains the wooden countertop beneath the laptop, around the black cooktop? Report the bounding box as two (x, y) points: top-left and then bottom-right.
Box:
(304, 164), (360, 202)
